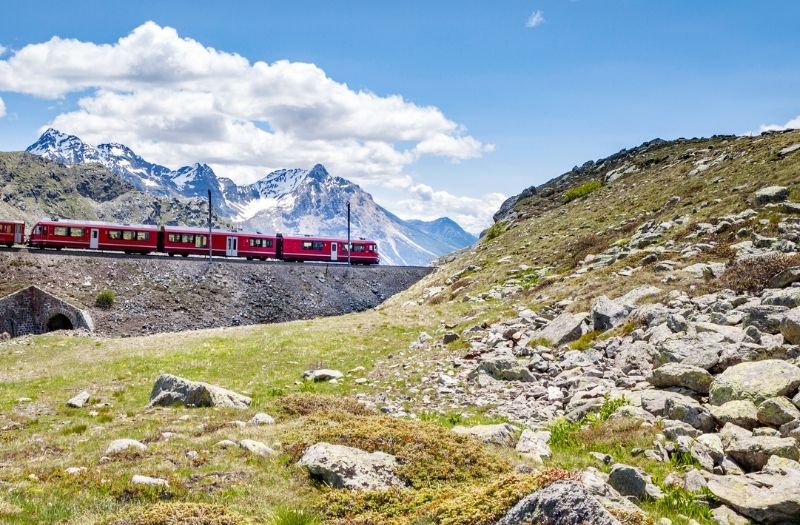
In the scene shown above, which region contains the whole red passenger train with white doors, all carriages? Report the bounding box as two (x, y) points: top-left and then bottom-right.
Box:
(15, 221), (380, 264)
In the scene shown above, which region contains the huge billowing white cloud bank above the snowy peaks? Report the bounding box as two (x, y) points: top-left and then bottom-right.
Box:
(0, 22), (493, 187)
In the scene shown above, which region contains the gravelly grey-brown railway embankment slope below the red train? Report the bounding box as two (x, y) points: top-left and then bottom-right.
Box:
(0, 249), (432, 336)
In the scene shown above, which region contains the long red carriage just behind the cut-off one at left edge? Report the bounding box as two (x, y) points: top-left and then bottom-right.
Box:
(28, 221), (158, 254)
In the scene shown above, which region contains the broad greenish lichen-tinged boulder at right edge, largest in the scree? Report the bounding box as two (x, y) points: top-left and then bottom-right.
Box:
(709, 359), (800, 405)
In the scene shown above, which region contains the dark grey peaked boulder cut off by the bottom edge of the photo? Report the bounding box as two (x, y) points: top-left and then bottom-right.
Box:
(497, 480), (620, 525)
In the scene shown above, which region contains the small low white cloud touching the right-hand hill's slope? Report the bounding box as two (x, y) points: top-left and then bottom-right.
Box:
(391, 184), (506, 234)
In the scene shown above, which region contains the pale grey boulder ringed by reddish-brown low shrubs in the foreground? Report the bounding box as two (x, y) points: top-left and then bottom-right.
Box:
(298, 443), (405, 490)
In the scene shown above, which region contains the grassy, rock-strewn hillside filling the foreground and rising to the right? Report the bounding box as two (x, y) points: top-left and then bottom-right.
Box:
(0, 132), (800, 525)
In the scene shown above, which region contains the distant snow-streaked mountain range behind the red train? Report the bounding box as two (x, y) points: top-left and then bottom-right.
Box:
(26, 129), (476, 265)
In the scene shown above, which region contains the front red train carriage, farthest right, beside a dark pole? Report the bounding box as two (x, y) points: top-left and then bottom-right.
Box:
(281, 236), (380, 264)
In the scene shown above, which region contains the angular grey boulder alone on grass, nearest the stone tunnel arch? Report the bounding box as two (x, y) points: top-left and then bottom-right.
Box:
(149, 374), (252, 408)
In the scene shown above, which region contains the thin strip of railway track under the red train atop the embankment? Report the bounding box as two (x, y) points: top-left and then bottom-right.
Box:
(0, 247), (435, 270)
